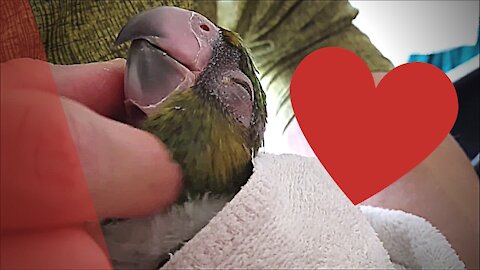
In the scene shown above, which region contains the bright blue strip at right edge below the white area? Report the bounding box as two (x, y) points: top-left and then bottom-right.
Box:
(408, 23), (480, 73)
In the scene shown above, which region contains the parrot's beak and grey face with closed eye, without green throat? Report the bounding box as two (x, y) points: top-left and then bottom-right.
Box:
(115, 7), (266, 152)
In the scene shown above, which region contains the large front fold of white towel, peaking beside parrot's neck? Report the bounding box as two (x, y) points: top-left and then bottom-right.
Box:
(164, 154), (393, 269)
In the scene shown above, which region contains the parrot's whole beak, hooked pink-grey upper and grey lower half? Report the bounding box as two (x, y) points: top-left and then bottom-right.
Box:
(115, 7), (220, 124)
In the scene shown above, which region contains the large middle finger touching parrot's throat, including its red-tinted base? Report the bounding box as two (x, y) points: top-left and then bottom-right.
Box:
(0, 88), (181, 231)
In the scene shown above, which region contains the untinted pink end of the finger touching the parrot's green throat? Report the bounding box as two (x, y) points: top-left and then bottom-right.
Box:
(62, 98), (181, 217)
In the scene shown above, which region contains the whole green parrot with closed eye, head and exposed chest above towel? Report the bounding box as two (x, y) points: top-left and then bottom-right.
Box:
(102, 6), (267, 269)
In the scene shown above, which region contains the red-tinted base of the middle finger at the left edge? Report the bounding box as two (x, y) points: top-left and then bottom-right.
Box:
(0, 88), (101, 232)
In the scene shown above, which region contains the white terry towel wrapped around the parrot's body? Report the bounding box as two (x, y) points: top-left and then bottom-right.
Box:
(102, 154), (464, 269)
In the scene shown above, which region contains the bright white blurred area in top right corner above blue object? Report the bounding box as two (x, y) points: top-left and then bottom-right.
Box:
(350, 0), (480, 68)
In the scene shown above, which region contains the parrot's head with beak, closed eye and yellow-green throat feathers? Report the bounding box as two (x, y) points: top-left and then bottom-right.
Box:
(116, 7), (266, 199)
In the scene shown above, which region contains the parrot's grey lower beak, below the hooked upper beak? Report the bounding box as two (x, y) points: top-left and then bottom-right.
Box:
(125, 39), (197, 124)
